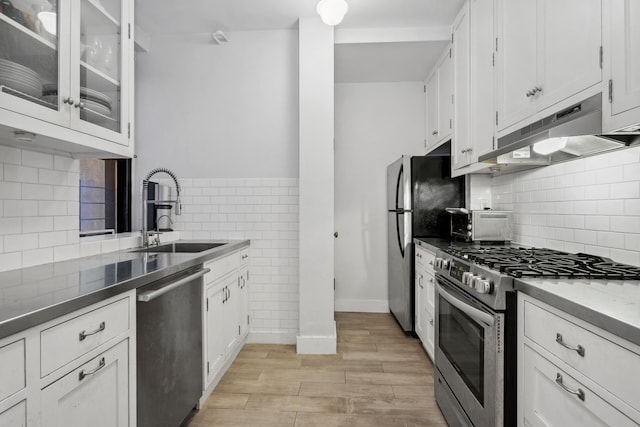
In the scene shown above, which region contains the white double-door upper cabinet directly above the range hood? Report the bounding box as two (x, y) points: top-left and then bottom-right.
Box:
(496, 0), (602, 131)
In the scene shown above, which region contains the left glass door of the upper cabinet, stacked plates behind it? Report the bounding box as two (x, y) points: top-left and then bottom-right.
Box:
(0, 0), (70, 126)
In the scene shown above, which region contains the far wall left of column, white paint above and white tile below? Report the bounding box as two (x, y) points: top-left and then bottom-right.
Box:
(134, 30), (299, 344)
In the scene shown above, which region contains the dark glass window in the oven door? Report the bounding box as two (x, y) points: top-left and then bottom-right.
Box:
(438, 297), (484, 407)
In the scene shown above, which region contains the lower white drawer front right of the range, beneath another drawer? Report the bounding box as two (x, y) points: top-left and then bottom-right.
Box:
(522, 345), (637, 427)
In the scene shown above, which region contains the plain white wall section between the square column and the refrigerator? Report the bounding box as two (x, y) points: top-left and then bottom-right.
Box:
(335, 82), (425, 312)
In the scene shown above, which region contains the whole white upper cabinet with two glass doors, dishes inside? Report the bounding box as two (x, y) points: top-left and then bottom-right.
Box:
(0, 0), (133, 155)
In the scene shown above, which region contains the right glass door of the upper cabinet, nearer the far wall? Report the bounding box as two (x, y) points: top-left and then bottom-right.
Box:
(71, 0), (129, 142)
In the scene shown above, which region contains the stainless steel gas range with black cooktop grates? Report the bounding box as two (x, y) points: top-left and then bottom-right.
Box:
(435, 245), (640, 427)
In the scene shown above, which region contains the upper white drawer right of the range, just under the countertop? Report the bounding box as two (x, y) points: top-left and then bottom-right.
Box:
(524, 301), (640, 410)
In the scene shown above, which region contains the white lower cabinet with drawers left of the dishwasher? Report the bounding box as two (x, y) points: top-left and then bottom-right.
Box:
(0, 290), (136, 427)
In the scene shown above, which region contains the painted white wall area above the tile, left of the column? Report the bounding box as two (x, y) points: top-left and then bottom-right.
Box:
(136, 30), (298, 178)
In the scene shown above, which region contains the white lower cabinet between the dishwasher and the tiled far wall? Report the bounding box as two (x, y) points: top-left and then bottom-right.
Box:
(200, 248), (249, 403)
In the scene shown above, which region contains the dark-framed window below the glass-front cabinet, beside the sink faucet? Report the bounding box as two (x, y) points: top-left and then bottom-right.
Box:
(80, 159), (131, 237)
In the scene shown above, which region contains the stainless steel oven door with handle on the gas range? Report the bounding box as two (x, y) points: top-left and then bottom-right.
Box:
(435, 275), (504, 426)
